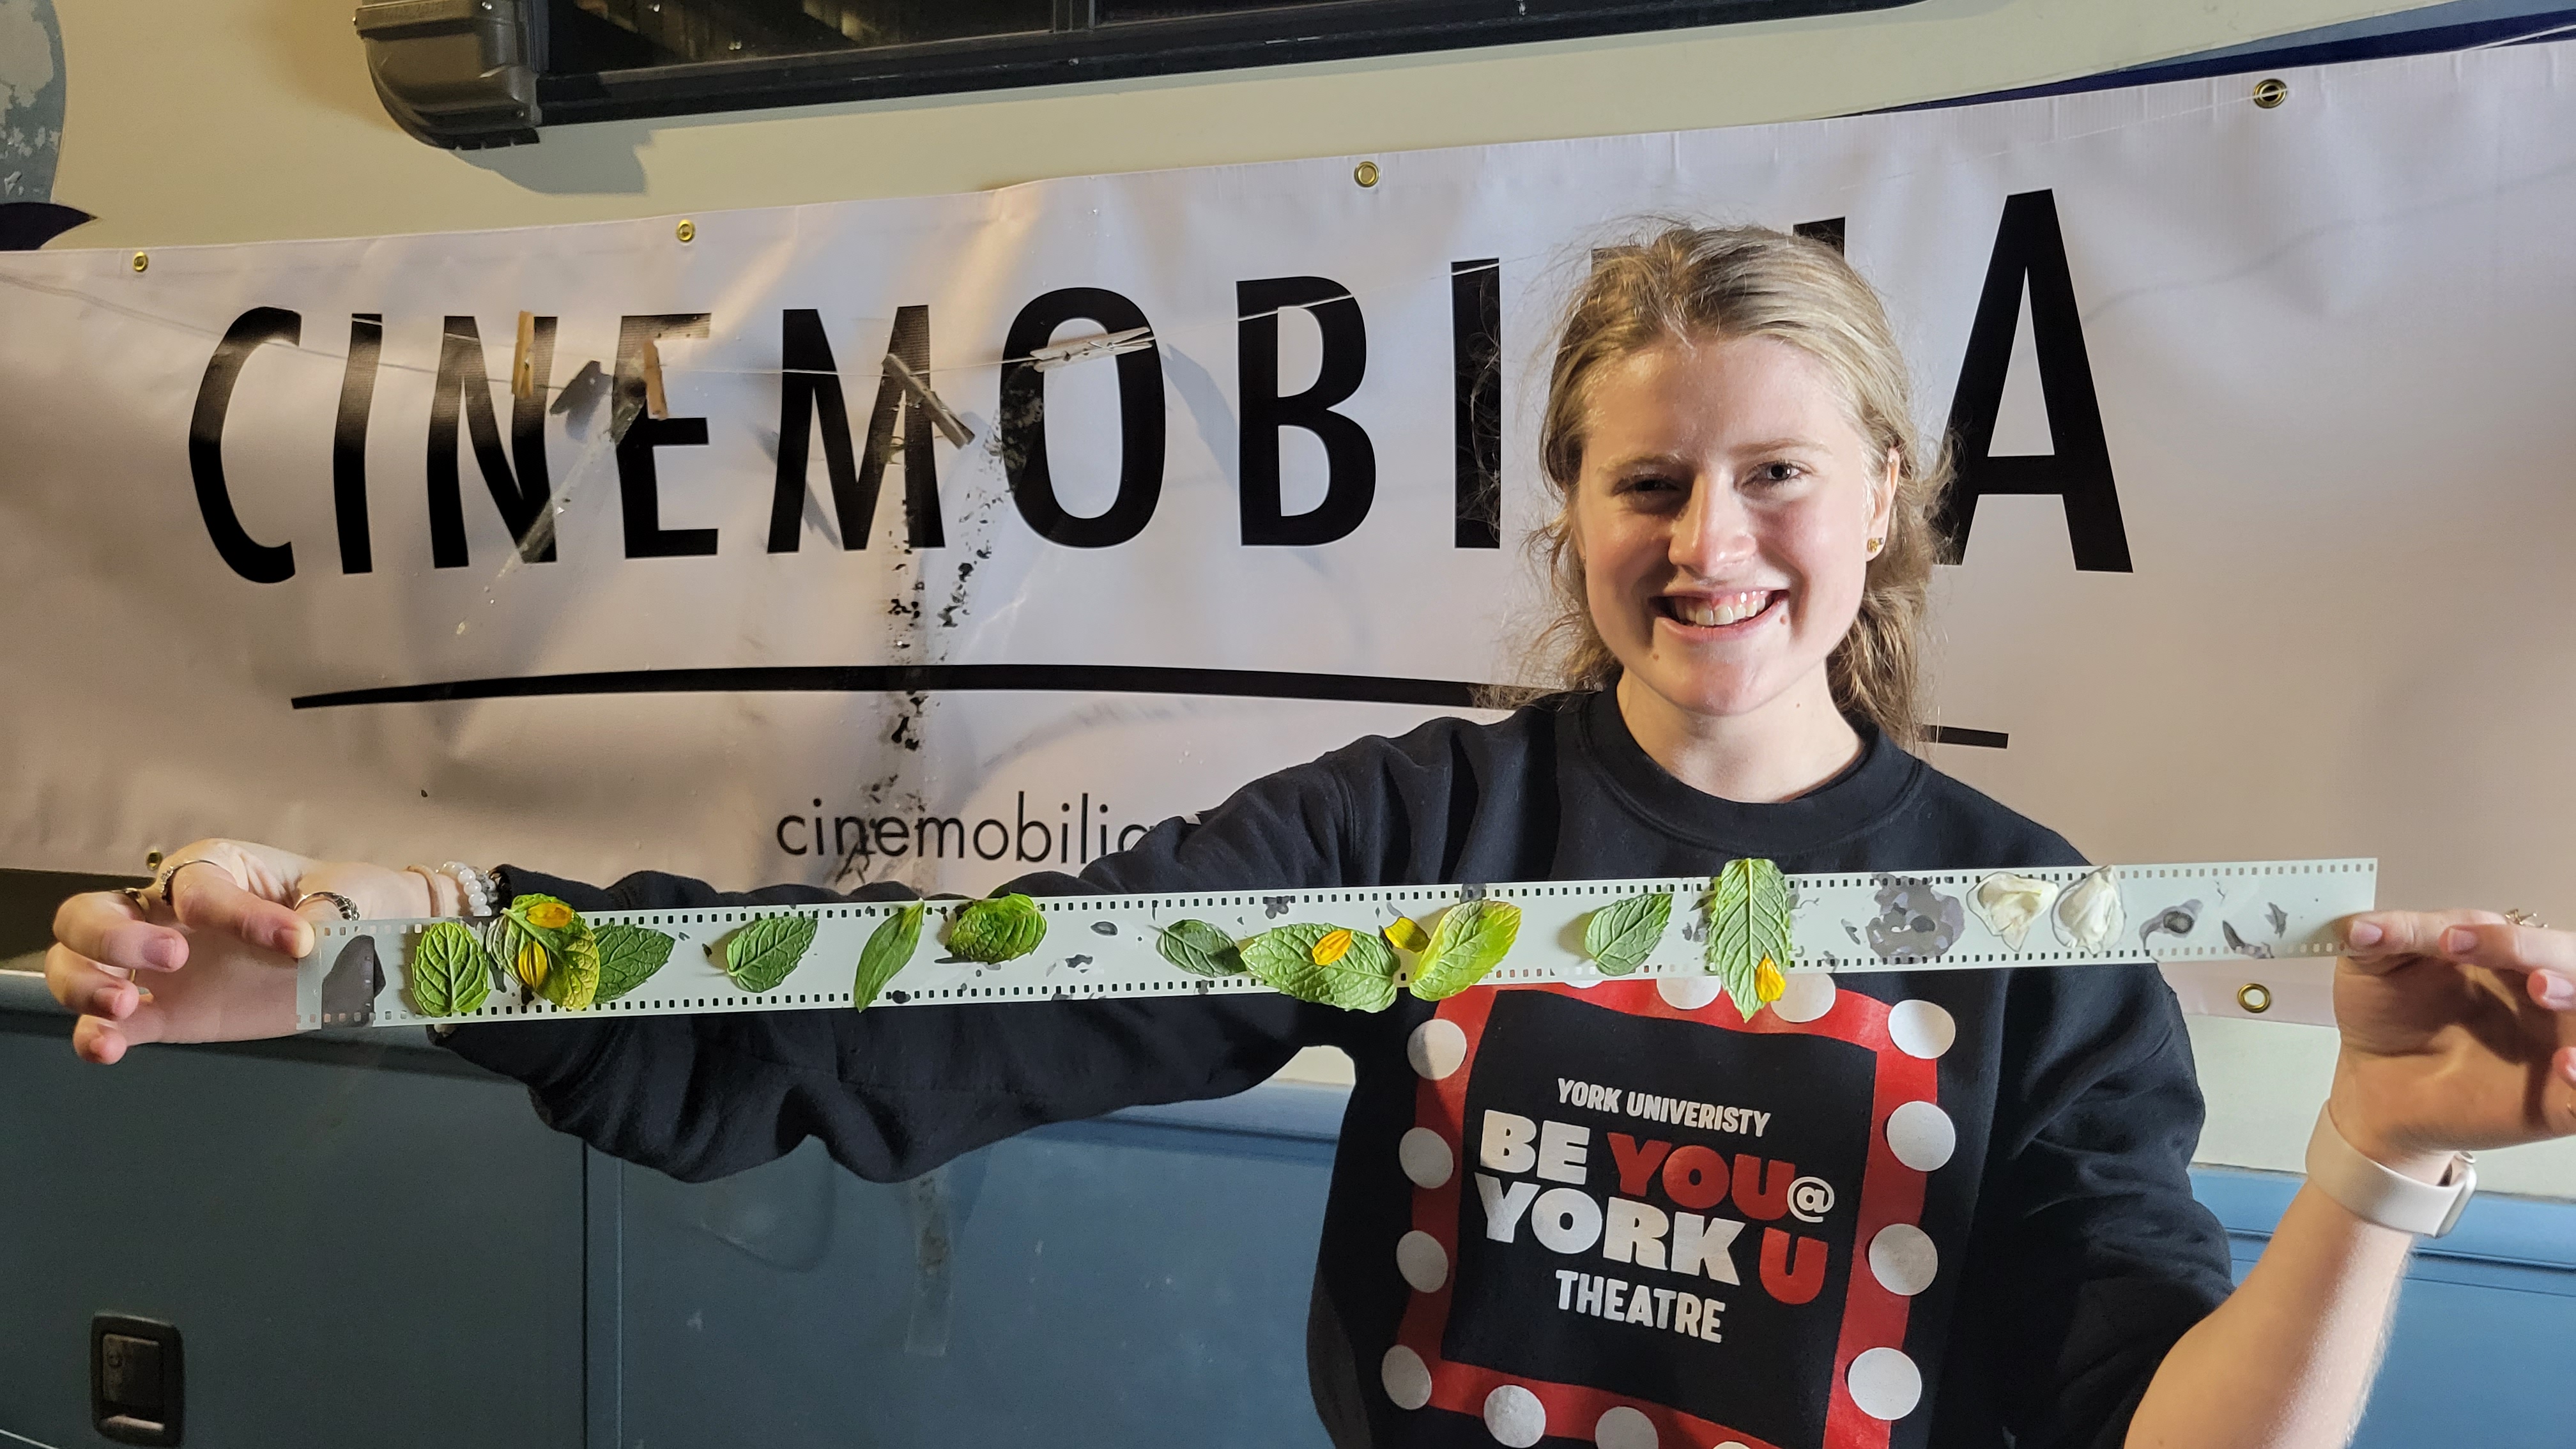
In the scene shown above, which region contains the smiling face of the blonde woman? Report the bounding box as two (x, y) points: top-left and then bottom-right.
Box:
(1574, 338), (1894, 717)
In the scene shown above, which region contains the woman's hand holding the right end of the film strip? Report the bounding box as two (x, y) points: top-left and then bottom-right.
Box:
(2331, 910), (2576, 1178)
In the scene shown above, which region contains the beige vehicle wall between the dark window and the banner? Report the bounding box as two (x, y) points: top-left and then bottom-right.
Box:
(54, 0), (2411, 247)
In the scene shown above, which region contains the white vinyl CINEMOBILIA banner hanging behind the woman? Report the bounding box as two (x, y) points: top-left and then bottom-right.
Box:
(0, 47), (2576, 990)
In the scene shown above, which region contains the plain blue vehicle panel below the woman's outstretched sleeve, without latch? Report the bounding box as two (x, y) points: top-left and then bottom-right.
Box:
(600, 1088), (1342, 1449)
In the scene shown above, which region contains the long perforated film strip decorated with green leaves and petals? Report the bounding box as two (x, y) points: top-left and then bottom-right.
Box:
(296, 859), (2378, 1031)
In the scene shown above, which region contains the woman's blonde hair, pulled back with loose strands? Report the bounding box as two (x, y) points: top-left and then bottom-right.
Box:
(1530, 222), (1950, 745)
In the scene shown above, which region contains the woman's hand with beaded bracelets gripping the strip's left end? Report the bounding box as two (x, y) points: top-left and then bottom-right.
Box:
(44, 841), (430, 1062)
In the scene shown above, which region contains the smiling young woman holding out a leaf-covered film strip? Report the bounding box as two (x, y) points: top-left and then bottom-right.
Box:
(49, 229), (2576, 1449)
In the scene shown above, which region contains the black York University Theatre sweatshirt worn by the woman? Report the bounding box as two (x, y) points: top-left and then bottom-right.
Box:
(448, 694), (2228, 1449)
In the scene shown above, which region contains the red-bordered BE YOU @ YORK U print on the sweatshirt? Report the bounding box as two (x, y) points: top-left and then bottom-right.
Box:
(1381, 974), (1955, 1449)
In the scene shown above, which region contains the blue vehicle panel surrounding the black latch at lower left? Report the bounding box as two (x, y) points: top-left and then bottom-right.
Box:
(0, 1013), (582, 1449)
